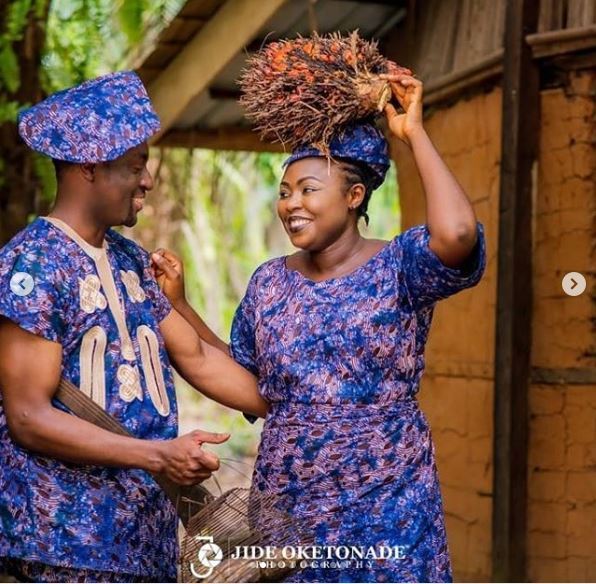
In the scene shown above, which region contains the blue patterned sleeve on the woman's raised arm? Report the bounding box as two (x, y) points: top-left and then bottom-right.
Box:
(398, 223), (486, 308)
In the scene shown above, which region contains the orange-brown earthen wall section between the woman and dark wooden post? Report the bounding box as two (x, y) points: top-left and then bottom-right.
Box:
(392, 89), (501, 581)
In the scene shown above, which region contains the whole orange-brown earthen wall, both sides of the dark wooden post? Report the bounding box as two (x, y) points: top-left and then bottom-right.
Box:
(392, 67), (596, 582)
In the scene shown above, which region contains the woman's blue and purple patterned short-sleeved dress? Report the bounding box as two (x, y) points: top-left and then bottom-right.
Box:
(231, 225), (485, 582)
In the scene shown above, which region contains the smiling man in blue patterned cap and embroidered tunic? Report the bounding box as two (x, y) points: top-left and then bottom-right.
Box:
(0, 72), (266, 582)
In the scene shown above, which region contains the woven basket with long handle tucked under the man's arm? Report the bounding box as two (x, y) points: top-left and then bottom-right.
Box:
(54, 379), (312, 582)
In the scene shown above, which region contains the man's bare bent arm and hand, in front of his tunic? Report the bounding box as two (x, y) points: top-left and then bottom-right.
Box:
(0, 317), (229, 476)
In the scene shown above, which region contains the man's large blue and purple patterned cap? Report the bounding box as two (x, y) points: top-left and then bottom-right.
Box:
(19, 71), (159, 164)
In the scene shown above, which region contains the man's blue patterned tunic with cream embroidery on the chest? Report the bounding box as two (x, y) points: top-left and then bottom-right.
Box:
(0, 218), (177, 581)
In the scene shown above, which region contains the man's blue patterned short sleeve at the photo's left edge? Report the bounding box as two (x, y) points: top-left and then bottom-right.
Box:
(0, 245), (69, 343)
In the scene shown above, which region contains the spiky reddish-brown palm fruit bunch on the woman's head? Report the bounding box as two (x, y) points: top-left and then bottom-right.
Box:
(239, 31), (411, 154)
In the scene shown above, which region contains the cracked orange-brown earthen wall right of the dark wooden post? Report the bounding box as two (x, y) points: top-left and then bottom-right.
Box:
(527, 72), (596, 582)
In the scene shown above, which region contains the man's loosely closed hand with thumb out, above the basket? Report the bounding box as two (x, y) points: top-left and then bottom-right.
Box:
(156, 430), (230, 485)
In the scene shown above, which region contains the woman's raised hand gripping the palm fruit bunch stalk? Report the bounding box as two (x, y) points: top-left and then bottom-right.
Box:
(381, 74), (424, 146)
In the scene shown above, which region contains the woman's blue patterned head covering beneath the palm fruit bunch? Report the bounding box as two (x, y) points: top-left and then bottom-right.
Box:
(283, 122), (389, 189)
